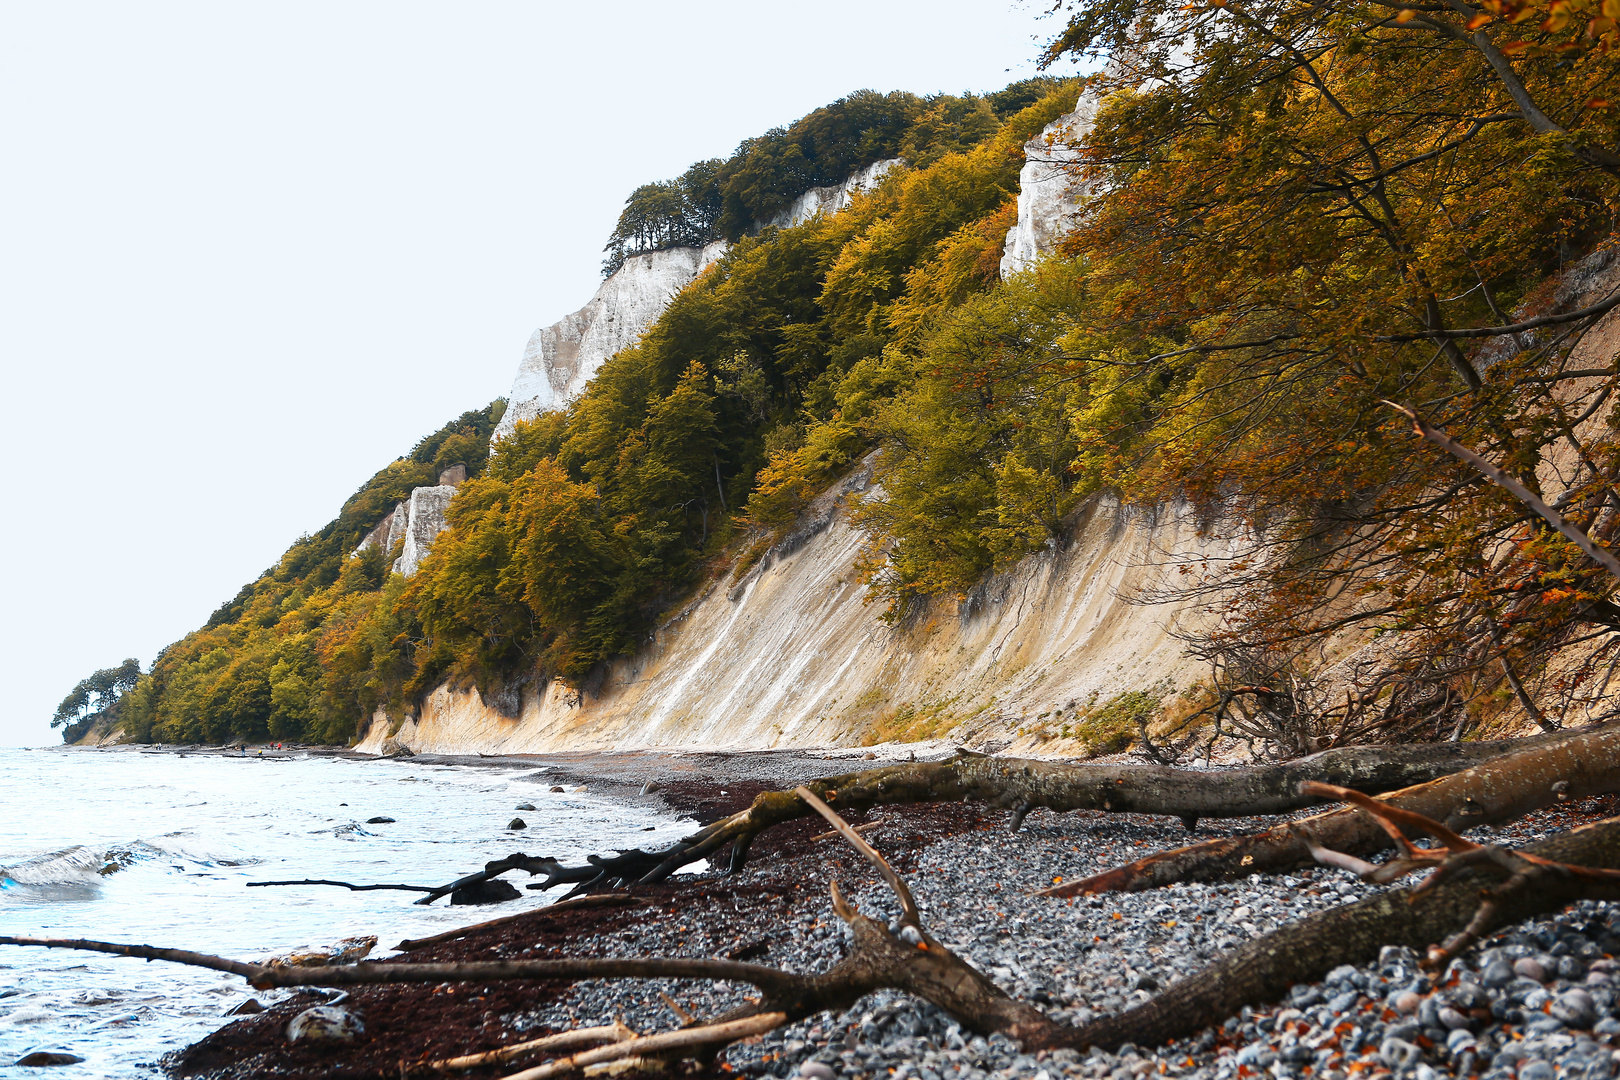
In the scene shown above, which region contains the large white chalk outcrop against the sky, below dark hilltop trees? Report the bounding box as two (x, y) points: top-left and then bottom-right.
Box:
(494, 240), (726, 442)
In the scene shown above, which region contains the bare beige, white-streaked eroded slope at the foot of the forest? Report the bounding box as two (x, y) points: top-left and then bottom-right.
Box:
(360, 461), (1226, 753)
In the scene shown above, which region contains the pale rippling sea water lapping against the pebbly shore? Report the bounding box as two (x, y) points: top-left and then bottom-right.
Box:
(0, 748), (692, 1080)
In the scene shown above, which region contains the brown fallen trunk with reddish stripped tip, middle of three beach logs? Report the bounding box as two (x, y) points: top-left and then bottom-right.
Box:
(1042, 727), (1620, 897)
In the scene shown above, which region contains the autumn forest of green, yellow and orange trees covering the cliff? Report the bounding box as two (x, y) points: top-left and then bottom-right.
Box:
(66, 0), (1620, 753)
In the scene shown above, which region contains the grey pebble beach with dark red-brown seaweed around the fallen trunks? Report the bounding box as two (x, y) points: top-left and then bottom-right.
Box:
(165, 755), (1620, 1080)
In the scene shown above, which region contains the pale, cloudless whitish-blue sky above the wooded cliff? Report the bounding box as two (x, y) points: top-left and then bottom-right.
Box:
(0, 0), (1058, 745)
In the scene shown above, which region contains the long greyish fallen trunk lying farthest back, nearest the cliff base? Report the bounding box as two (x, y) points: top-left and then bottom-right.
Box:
(631, 725), (1620, 887)
